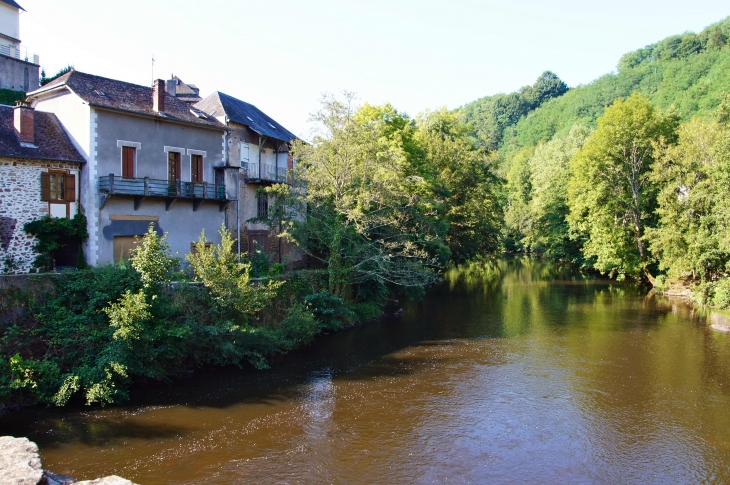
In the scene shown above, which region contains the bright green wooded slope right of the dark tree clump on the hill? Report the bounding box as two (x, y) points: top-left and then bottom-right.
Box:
(500, 17), (730, 154)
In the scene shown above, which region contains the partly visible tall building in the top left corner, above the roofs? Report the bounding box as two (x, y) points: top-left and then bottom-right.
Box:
(0, 0), (40, 92)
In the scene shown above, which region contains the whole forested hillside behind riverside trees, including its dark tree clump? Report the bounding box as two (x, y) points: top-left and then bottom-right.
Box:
(461, 17), (730, 158)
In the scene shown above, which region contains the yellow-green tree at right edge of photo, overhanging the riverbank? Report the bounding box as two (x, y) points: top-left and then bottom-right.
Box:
(647, 118), (730, 281)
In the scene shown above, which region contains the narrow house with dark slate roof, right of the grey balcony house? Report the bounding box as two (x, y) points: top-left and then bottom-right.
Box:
(193, 92), (302, 266)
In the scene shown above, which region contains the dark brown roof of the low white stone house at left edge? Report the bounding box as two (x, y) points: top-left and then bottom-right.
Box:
(0, 105), (85, 162)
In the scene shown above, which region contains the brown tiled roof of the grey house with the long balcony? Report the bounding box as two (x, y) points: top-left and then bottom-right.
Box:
(28, 70), (225, 129)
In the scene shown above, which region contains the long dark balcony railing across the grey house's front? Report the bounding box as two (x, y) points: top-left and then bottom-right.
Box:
(99, 174), (226, 200)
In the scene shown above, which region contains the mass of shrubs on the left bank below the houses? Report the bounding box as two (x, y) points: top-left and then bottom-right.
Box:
(0, 225), (382, 405)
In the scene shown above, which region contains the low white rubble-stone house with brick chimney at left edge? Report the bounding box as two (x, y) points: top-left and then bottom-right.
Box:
(0, 103), (85, 273)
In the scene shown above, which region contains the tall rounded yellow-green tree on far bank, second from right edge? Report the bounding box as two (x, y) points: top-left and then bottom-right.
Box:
(568, 93), (677, 280)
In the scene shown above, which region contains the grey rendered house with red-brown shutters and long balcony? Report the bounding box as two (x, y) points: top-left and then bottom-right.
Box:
(27, 70), (239, 265)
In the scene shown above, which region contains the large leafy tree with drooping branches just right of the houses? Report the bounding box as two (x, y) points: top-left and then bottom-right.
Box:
(284, 93), (445, 298)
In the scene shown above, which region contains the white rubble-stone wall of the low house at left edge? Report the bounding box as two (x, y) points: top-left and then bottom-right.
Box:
(0, 158), (79, 274)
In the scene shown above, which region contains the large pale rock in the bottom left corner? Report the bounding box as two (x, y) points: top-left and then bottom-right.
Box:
(0, 436), (43, 485)
